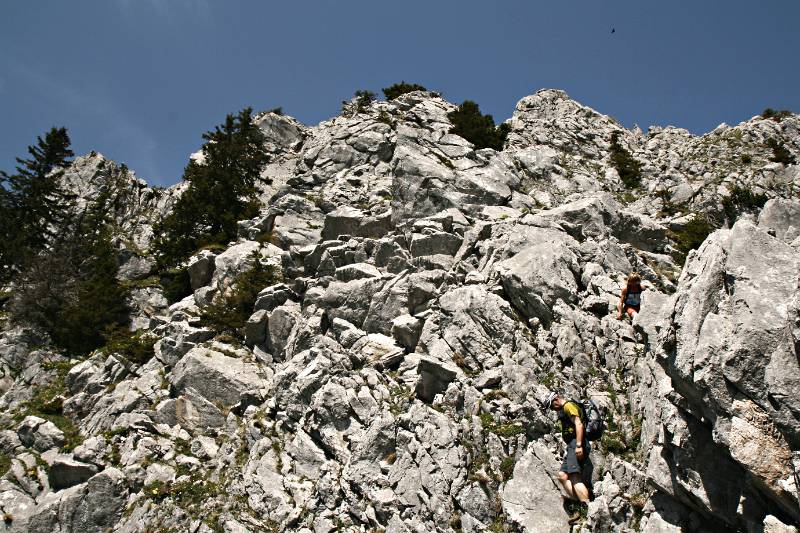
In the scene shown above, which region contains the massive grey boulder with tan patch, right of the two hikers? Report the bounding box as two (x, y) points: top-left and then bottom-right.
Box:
(655, 220), (800, 520)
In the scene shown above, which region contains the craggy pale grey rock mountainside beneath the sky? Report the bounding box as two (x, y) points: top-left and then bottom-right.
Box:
(0, 90), (800, 533)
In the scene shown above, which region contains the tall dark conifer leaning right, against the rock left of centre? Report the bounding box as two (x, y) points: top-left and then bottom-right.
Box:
(154, 108), (268, 269)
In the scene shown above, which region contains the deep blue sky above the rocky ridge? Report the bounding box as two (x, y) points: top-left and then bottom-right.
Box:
(0, 0), (800, 185)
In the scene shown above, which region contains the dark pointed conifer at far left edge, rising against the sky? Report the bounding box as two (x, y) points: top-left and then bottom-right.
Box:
(0, 128), (74, 278)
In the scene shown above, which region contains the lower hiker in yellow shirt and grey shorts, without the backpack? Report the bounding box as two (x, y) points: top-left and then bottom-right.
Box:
(542, 392), (592, 505)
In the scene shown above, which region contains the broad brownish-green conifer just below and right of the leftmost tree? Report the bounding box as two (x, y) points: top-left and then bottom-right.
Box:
(10, 186), (129, 355)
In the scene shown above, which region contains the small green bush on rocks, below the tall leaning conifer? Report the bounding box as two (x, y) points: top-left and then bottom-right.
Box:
(203, 252), (281, 338)
